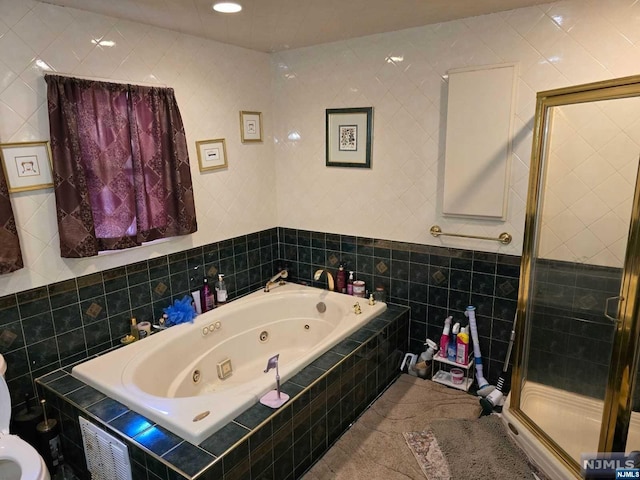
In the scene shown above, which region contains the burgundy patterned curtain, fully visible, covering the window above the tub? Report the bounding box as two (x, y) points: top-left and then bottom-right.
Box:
(45, 75), (197, 257)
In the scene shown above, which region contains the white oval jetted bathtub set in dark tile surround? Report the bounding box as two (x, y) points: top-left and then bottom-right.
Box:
(72, 284), (386, 444)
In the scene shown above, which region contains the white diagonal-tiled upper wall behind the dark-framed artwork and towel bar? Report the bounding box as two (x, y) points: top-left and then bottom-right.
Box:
(271, 0), (640, 259)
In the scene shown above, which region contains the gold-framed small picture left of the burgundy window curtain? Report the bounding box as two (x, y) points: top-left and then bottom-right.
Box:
(0, 142), (53, 193)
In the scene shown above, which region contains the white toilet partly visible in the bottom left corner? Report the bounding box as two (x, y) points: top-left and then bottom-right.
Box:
(0, 355), (51, 480)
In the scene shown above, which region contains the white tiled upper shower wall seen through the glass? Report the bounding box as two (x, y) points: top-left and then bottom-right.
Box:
(540, 98), (640, 268)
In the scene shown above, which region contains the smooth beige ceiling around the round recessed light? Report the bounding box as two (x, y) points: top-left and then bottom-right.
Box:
(40, 0), (549, 52)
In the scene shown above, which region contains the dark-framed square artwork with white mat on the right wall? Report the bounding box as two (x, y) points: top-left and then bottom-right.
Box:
(326, 107), (373, 168)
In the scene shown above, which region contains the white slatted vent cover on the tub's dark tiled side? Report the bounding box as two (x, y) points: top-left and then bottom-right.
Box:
(78, 417), (132, 480)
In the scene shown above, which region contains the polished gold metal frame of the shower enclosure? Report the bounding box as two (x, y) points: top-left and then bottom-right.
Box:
(510, 75), (640, 476)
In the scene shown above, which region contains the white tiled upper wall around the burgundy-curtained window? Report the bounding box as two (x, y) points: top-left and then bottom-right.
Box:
(0, 0), (277, 295)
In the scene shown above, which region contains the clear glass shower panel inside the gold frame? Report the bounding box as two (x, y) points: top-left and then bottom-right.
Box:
(519, 94), (640, 462)
